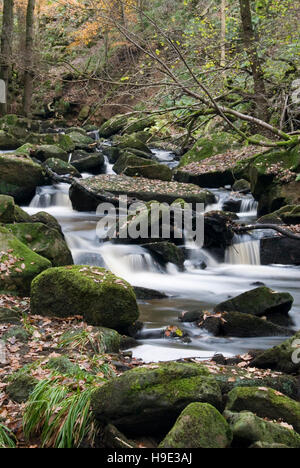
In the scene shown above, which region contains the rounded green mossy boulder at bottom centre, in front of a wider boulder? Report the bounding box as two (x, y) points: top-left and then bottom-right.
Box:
(159, 403), (232, 449)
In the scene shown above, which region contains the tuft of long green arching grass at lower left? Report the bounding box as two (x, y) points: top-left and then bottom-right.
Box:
(23, 375), (97, 448)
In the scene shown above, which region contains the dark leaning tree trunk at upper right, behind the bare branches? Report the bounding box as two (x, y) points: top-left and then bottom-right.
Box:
(239, 0), (268, 121)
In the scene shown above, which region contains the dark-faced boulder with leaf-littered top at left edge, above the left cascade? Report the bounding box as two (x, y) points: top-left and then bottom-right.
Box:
(0, 153), (45, 203)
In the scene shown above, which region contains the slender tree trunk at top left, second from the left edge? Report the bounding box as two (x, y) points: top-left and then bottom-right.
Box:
(23, 0), (35, 116)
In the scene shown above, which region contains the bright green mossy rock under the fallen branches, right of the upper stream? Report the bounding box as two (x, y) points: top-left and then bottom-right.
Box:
(179, 132), (240, 167)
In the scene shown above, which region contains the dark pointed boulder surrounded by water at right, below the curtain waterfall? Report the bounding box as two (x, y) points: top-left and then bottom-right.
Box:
(214, 286), (294, 317)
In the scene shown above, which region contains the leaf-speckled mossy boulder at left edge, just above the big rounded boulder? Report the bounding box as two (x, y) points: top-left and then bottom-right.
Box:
(0, 226), (52, 296)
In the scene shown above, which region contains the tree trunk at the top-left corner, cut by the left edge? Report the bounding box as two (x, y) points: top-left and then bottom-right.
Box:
(0, 0), (14, 115)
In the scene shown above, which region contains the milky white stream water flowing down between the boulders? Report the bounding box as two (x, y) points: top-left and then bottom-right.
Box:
(24, 150), (300, 361)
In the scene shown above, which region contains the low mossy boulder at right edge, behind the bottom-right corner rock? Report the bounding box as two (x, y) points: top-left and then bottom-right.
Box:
(226, 387), (300, 432)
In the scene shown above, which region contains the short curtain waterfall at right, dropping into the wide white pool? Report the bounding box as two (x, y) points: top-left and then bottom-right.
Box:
(225, 235), (260, 265)
